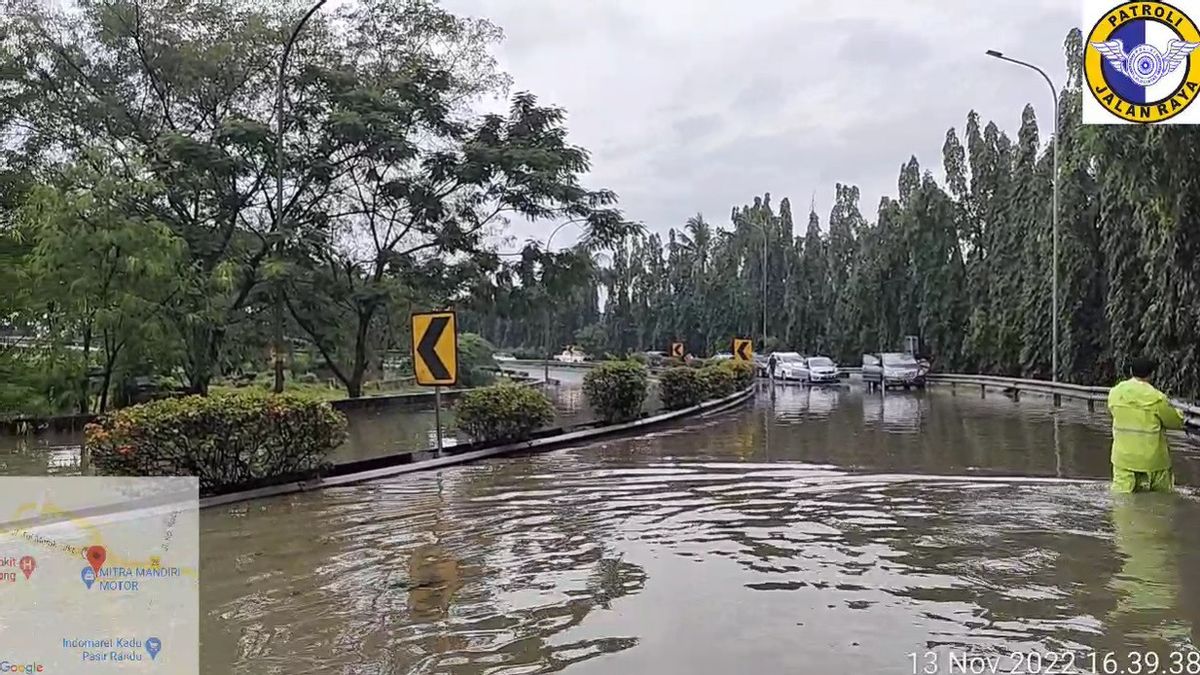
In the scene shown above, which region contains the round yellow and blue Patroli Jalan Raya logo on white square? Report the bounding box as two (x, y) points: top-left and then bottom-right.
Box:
(1084, 0), (1200, 124)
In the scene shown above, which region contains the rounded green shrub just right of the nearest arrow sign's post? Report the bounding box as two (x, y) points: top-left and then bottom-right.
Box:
(456, 384), (554, 442)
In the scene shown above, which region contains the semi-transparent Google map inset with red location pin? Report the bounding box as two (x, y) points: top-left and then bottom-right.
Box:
(0, 477), (199, 675)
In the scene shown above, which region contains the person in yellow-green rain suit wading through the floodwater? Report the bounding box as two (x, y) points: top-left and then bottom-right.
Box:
(1109, 358), (1183, 492)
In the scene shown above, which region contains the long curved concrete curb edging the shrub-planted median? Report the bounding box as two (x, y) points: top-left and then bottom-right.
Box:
(200, 386), (755, 508)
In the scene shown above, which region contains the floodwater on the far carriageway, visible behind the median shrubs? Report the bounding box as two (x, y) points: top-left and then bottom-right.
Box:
(0, 369), (595, 476)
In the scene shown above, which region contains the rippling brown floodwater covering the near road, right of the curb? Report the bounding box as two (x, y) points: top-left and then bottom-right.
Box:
(202, 386), (1200, 675)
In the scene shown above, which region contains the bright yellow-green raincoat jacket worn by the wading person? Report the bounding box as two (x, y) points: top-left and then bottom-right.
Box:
(1109, 378), (1183, 471)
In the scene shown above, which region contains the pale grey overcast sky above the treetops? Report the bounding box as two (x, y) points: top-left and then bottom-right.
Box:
(443, 0), (1081, 249)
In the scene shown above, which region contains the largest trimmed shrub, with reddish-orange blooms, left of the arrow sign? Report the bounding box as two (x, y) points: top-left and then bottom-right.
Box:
(84, 392), (346, 494)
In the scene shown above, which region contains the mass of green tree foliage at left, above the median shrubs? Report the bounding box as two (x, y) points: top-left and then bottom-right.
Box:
(0, 0), (637, 406)
